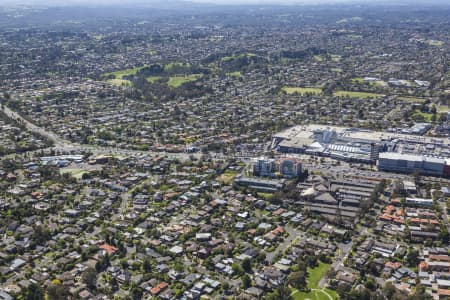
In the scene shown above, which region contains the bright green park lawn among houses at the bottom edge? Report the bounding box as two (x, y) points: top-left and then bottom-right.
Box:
(292, 262), (339, 300)
